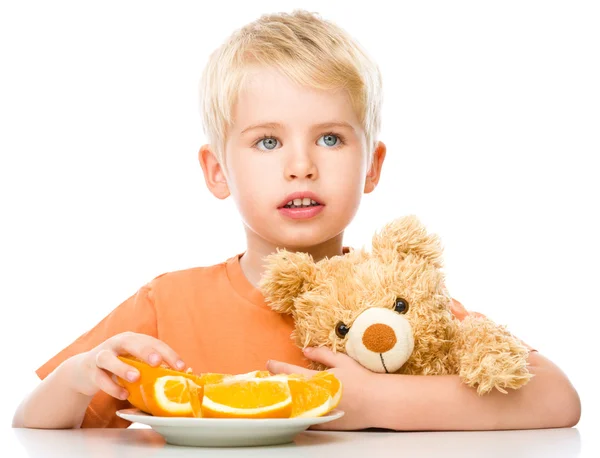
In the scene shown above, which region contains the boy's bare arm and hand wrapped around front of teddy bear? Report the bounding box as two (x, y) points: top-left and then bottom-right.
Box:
(267, 348), (581, 431)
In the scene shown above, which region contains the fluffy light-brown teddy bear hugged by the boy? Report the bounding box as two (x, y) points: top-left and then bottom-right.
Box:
(259, 215), (533, 395)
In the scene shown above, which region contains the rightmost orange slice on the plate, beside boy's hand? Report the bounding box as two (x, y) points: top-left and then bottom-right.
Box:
(288, 377), (332, 417)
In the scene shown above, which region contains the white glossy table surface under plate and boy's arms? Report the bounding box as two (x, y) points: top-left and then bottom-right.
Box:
(0, 427), (600, 458)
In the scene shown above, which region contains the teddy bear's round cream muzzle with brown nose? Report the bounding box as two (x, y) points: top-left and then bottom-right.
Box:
(346, 307), (414, 373)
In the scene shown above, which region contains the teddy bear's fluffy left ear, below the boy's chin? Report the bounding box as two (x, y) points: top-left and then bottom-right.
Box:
(259, 250), (317, 314)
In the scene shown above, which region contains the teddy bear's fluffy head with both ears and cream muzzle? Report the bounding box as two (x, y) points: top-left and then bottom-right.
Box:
(260, 216), (455, 373)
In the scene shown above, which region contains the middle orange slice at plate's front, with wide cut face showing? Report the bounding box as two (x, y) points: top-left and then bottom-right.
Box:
(202, 378), (292, 418)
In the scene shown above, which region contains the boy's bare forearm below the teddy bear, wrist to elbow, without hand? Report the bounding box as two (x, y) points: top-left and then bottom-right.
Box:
(364, 352), (581, 431)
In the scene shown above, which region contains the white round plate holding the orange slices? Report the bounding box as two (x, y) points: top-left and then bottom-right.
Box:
(117, 409), (344, 447)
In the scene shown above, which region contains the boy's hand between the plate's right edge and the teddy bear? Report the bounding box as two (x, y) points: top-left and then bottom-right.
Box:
(267, 347), (375, 430)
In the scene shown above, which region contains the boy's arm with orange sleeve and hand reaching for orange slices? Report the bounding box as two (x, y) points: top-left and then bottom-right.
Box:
(13, 283), (178, 428)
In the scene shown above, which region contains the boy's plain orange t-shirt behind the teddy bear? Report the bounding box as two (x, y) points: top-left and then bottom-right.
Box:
(36, 254), (510, 427)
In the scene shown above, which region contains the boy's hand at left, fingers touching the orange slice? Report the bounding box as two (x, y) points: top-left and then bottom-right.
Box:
(70, 332), (185, 399)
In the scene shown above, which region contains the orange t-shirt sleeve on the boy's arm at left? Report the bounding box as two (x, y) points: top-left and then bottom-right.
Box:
(36, 284), (157, 428)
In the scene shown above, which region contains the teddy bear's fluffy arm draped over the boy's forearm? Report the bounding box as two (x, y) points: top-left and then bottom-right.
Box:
(454, 316), (533, 395)
